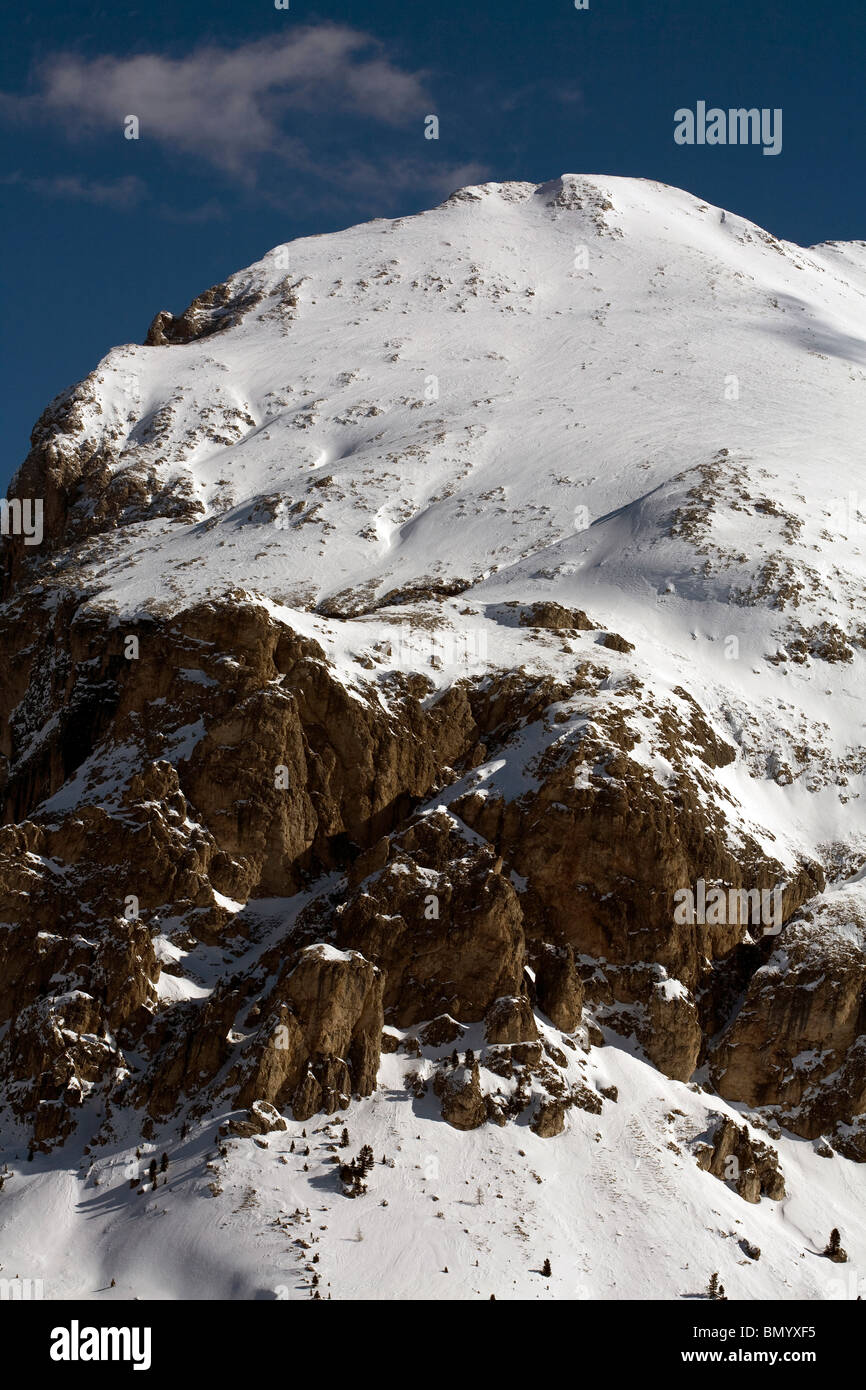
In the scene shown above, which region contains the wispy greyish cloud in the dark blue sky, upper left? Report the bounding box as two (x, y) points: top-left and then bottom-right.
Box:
(0, 24), (430, 181)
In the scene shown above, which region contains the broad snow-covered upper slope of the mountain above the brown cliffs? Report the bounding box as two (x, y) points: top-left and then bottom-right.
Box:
(44, 175), (866, 625)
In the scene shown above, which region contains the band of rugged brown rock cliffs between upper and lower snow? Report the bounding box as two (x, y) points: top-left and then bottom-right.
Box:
(0, 569), (863, 1148)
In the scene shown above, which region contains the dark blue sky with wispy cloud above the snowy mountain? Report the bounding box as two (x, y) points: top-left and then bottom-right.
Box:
(0, 0), (866, 487)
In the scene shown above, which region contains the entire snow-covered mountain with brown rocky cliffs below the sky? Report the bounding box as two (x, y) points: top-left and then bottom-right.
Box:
(0, 175), (866, 1298)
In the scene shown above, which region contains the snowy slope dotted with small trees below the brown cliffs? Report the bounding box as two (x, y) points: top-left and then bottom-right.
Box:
(3, 1038), (866, 1300)
